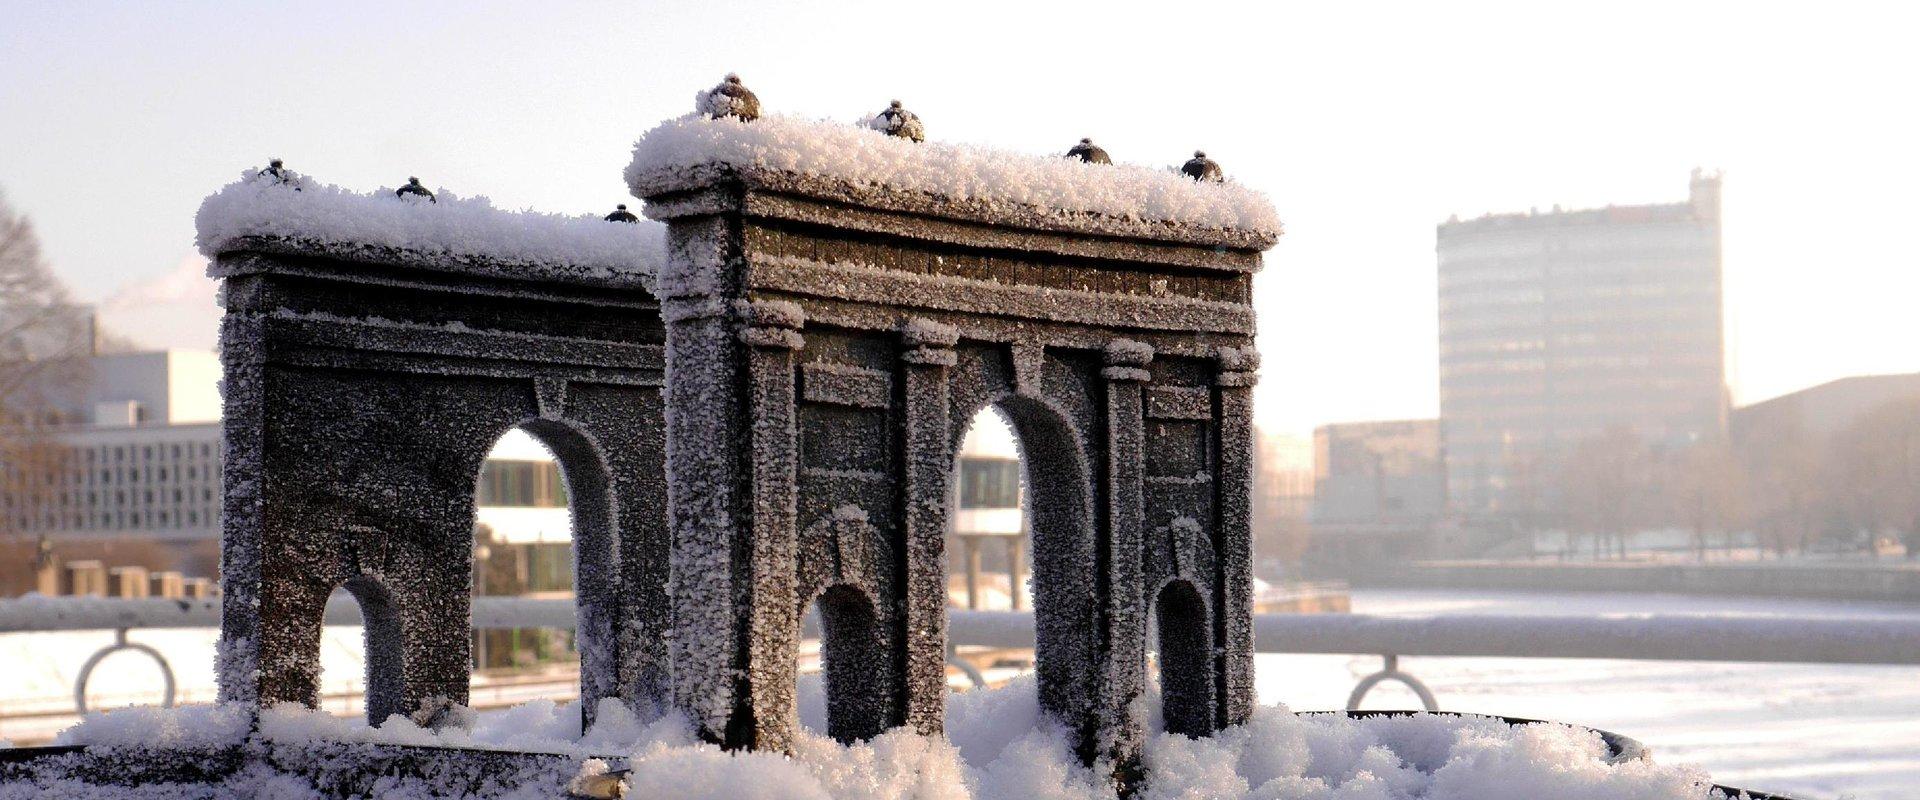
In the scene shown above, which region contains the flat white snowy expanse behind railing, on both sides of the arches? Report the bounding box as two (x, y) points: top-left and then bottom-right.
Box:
(0, 591), (1920, 800)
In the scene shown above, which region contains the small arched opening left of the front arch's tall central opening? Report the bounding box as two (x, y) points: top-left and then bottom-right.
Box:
(814, 583), (893, 742)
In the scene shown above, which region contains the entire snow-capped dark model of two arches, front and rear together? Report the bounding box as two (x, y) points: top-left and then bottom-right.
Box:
(200, 92), (1279, 786)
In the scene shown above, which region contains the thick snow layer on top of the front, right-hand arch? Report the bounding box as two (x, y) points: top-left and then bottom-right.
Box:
(626, 113), (1281, 234)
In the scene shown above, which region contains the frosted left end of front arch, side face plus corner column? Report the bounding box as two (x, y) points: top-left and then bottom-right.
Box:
(660, 215), (804, 750)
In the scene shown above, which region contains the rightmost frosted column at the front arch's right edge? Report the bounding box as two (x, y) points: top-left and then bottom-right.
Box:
(1213, 345), (1260, 727)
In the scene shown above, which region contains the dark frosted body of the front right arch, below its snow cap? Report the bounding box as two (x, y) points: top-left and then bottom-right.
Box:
(647, 175), (1260, 779)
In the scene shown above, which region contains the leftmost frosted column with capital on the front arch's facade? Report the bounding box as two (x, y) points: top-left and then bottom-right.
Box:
(735, 301), (806, 750)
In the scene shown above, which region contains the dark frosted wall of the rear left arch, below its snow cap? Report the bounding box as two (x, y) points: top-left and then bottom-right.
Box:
(213, 242), (668, 721)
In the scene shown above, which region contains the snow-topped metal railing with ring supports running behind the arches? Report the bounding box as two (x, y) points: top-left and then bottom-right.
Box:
(0, 597), (1920, 712)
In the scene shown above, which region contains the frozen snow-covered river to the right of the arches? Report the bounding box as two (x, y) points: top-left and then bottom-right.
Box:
(1258, 591), (1920, 800)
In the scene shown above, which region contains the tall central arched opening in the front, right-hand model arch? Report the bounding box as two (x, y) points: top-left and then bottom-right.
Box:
(948, 395), (1106, 721)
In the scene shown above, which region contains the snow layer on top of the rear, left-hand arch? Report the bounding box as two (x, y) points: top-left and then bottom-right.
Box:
(194, 169), (666, 276)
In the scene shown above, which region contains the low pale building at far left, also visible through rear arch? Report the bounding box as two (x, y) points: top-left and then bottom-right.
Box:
(0, 351), (572, 591)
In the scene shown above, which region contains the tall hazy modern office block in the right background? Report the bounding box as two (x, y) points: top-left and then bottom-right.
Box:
(1436, 171), (1728, 514)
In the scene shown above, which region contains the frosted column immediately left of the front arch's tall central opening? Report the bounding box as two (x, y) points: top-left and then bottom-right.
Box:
(900, 318), (960, 735)
